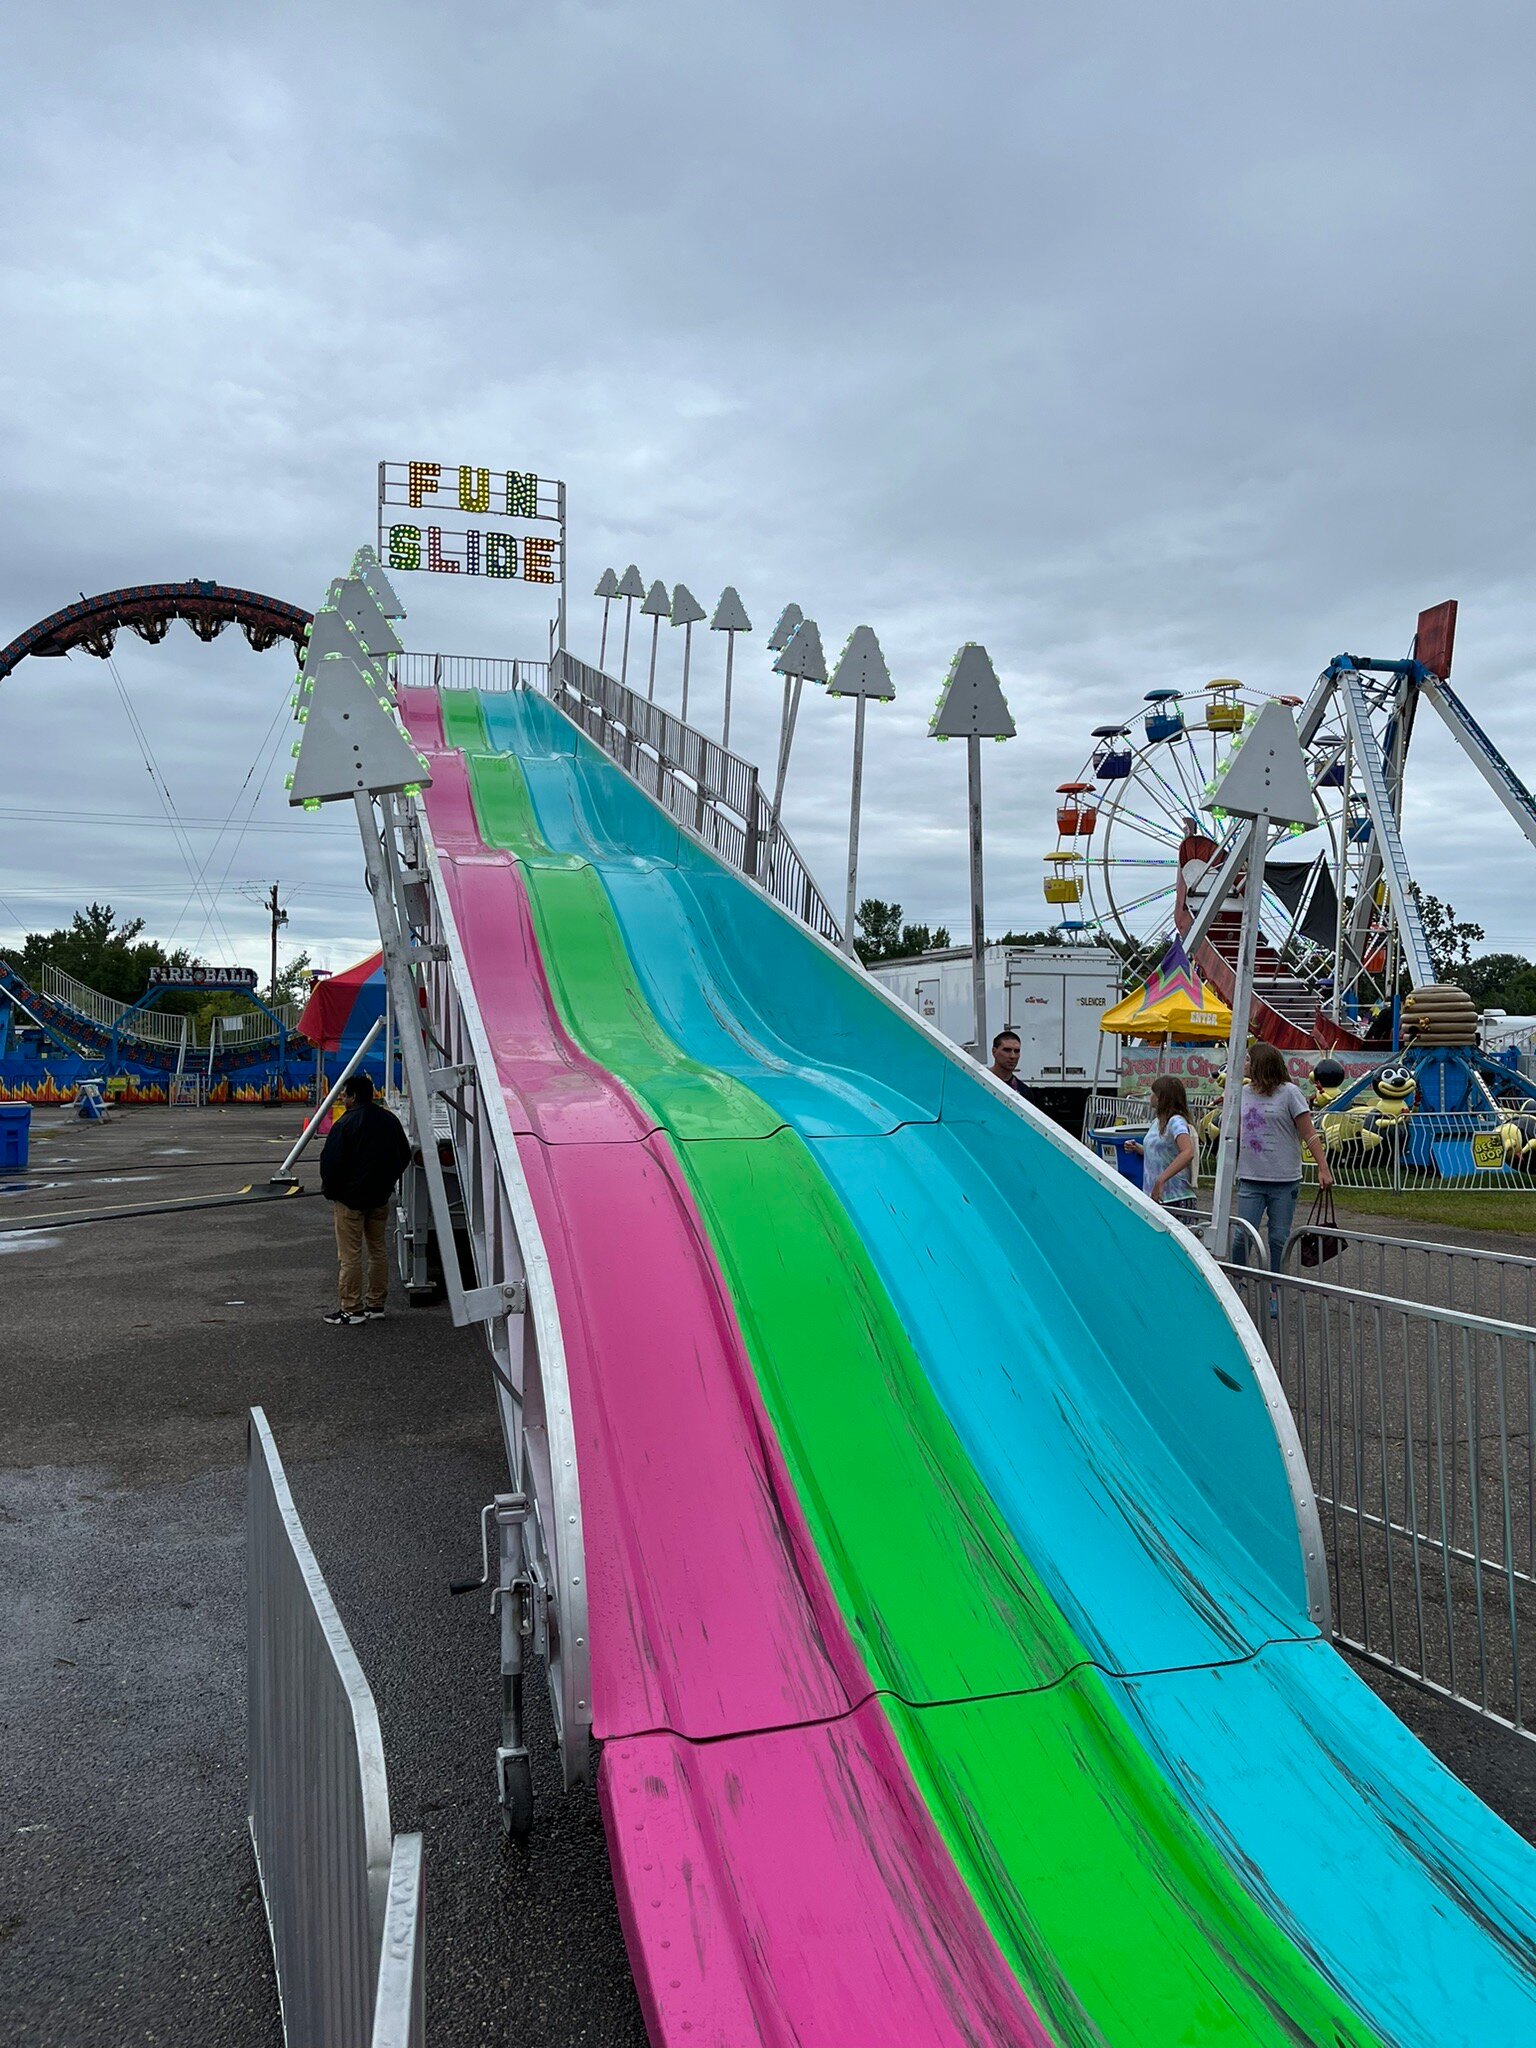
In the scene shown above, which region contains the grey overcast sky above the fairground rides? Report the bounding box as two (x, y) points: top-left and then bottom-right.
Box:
(0, 0), (1536, 967)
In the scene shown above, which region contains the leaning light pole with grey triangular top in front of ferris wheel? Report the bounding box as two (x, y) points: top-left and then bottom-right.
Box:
(1194, 702), (1317, 1260)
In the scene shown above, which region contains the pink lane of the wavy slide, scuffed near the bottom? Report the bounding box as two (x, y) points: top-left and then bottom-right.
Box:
(406, 692), (1047, 2048)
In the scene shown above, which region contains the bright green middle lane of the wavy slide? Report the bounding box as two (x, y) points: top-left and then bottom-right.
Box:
(442, 690), (1376, 2048)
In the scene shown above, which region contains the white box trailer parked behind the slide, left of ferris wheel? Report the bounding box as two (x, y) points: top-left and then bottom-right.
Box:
(870, 946), (1120, 1137)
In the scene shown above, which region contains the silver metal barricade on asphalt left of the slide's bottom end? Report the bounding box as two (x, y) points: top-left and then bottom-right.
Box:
(246, 1407), (424, 2048)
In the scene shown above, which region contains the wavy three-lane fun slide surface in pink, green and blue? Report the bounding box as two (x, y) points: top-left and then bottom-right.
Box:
(401, 690), (1536, 2048)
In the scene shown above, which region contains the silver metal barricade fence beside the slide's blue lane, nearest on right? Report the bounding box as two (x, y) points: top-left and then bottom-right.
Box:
(1227, 1266), (1536, 1739)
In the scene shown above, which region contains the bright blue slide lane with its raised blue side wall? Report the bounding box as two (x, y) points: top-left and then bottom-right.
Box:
(485, 692), (1536, 2048)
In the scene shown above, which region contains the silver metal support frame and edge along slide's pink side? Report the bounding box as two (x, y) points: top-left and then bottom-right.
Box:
(354, 795), (592, 1833)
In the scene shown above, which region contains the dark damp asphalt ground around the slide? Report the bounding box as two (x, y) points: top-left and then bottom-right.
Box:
(0, 1108), (1536, 2048)
